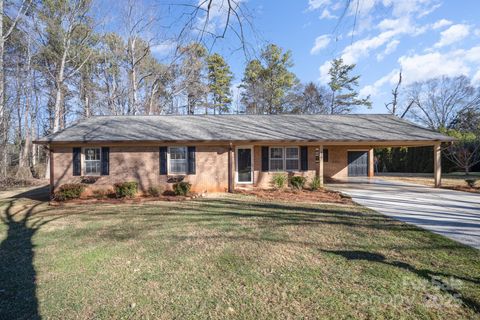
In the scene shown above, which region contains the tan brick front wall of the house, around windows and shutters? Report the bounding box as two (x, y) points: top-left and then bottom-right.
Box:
(53, 146), (376, 192)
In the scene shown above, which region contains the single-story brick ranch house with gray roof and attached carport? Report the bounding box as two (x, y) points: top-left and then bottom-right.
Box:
(36, 114), (452, 196)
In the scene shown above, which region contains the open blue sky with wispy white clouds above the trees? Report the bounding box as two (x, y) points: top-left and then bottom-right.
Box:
(219, 0), (480, 113)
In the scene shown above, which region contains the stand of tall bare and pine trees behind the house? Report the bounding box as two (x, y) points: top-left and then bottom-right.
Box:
(0, 0), (480, 179)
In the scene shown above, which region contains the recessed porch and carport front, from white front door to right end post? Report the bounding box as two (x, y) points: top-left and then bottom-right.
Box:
(228, 142), (442, 192)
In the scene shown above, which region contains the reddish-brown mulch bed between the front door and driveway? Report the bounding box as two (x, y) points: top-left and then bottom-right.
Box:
(236, 189), (354, 204)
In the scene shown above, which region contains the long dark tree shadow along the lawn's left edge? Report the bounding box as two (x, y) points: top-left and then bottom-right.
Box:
(0, 186), (59, 319)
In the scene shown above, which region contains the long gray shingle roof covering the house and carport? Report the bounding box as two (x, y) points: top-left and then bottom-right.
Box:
(38, 114), (453, 143)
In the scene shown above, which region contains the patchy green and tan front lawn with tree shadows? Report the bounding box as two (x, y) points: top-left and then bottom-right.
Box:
(0, 186), (480, 320)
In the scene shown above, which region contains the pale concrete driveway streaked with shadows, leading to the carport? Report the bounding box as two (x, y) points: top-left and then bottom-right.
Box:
(328, 179), (480, 249)
